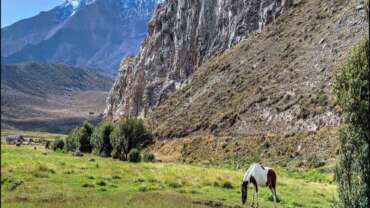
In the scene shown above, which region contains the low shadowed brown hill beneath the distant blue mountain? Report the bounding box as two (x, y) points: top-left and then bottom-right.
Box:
(1, 63), (113, 132)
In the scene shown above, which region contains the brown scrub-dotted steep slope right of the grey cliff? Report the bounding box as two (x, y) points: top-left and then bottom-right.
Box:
(148, 0), (368, 162)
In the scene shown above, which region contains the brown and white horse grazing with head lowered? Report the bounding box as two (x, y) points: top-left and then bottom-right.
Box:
(242, 163), (276, 207)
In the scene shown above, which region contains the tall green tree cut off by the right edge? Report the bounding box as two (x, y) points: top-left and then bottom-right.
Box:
(334, 35), (370, 208)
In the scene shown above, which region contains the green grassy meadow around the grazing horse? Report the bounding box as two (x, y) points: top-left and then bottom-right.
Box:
(1, 145), (336, 208)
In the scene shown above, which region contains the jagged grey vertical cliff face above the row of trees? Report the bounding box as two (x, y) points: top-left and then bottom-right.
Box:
(105, 0), (292, 120)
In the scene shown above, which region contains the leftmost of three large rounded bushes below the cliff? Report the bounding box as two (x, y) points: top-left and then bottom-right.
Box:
(66, 122), (94, 153)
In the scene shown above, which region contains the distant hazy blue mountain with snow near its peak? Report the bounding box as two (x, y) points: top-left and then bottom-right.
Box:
(1, 0), (159, 74)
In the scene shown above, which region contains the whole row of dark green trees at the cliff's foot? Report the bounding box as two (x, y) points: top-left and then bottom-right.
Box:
(46, 117), (155, 162)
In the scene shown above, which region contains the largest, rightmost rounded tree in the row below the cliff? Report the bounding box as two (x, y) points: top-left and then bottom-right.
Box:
(112, 117), (152, 160)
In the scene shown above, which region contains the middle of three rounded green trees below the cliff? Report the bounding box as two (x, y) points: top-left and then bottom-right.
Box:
(91, 122), (114, 157)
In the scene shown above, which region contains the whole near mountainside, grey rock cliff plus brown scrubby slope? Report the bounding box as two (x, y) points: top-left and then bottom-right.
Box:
(105, 0), (368, 164)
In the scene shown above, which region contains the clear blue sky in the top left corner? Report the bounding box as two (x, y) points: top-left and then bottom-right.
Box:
(1, 0), (65, 27)
